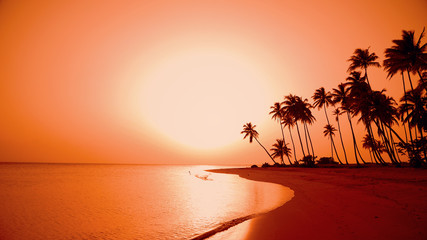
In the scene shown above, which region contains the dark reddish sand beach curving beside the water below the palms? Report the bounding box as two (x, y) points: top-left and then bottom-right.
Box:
(212, 167), (427, 240)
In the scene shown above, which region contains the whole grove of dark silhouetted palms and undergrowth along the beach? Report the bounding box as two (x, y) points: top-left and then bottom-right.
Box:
(242, 28), (427, 167)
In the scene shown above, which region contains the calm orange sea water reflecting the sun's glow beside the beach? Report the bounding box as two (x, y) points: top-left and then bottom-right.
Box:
(0, 164), (292, 240)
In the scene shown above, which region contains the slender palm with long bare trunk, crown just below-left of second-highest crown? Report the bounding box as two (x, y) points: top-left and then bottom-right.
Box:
(332, 83), (363, 165)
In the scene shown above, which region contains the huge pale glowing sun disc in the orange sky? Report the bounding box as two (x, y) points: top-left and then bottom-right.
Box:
(143, 49), (268, 149)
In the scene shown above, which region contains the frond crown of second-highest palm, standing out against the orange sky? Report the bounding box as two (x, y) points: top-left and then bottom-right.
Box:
(347, 48), (381, 88)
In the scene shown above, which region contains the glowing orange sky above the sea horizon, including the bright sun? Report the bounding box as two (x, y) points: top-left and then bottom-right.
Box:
(0, 0), (427, 164)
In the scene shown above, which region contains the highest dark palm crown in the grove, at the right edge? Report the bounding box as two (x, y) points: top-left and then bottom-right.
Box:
(383, 28), (427, 89)
